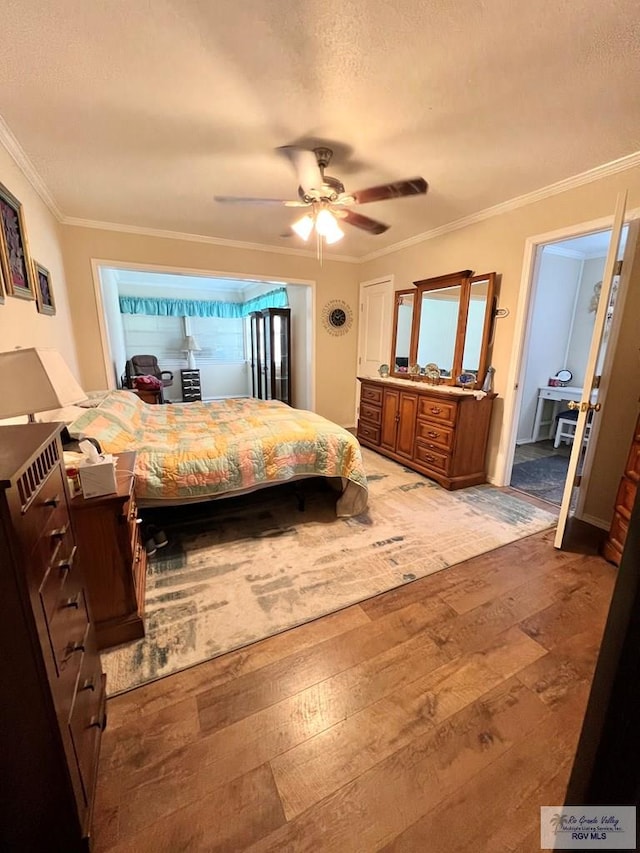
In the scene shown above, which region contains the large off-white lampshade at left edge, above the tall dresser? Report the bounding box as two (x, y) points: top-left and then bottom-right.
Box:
(0, 347), (87, 418)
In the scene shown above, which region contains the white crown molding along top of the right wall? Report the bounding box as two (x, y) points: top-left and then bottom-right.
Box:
(360, 151), (640, 263)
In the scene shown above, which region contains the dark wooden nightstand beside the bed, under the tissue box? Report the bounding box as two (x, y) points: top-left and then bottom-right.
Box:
(70, 451), (147, 649)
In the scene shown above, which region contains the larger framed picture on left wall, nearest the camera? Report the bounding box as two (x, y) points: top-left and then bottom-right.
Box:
(0, 184), (36, 299)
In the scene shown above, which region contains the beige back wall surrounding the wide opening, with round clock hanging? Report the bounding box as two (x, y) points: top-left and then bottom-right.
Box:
(62, 226), (359, 426)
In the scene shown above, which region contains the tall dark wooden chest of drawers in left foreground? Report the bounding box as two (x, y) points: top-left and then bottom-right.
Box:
(0, 424), (106, 853)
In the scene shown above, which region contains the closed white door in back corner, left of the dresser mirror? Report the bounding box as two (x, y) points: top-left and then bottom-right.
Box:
(356, 278), (393, 421)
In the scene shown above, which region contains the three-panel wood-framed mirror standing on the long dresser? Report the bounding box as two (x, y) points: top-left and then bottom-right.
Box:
(391, 270), (496, 388)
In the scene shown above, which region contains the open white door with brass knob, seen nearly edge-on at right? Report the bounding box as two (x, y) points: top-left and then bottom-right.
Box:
(553, 193), (627, 548)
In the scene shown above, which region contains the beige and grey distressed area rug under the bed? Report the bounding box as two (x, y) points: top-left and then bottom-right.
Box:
(102, 450), (556, 695)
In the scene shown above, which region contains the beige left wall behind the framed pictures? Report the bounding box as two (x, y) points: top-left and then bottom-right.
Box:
(0, 145), (80, 378)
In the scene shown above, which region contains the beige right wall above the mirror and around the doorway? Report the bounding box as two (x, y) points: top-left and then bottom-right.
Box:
(359, 169), (640, 522)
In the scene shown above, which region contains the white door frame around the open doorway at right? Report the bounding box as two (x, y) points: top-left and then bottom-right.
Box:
(491, 208), (640, 496)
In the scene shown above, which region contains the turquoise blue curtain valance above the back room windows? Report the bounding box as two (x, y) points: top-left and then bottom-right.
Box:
(120, 287), (289, 317)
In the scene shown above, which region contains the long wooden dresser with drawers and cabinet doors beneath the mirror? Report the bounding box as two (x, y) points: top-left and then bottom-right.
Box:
(357, 378), (496, 489)
